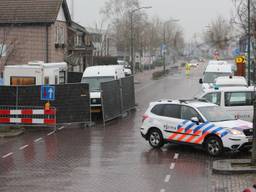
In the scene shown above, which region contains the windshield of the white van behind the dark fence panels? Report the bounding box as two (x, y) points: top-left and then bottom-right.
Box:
(82, 77), (115, 91)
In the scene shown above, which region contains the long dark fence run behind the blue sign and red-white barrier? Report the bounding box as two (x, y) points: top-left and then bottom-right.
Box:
(0, 83), (90, 123)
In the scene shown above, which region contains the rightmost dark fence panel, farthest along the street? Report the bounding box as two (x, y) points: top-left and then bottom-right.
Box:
(121, 76), (135, 112)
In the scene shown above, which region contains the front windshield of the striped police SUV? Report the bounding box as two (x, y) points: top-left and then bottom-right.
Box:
(198, 106), (235, 122)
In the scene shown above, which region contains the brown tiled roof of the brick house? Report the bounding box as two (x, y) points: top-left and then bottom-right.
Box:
(0, 0), (71, 24)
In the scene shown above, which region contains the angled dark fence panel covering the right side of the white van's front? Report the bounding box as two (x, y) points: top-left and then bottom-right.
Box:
(101, 80), (122, 122)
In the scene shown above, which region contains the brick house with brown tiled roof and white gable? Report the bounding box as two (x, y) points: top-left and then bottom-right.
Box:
(0, 0), (92, 72)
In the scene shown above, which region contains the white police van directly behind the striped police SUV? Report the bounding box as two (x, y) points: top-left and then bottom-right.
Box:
(199, 86), (255, 121)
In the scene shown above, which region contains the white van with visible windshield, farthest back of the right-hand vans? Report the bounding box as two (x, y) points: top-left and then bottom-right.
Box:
(199, 64), (233, 90)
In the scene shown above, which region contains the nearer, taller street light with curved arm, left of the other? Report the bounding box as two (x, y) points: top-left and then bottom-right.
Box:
(130, 6), (152, 74)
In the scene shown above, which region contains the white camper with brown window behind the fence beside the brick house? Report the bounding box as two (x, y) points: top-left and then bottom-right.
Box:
(3, 61), (67, 86)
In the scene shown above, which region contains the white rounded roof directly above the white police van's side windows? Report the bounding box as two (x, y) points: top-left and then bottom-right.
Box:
(214, 75), (248, 87)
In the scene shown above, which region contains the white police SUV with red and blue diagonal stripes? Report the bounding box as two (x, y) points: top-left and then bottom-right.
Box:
(141, 100), (253, 156)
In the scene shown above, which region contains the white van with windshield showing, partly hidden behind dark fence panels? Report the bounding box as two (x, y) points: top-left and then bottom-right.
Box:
(81, 65), (125, 113)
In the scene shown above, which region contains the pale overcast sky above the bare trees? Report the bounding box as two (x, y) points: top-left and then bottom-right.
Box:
(68, 0), (234, 40)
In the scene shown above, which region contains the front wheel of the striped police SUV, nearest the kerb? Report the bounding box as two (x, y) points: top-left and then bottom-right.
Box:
(205, 136), (223, 156)
